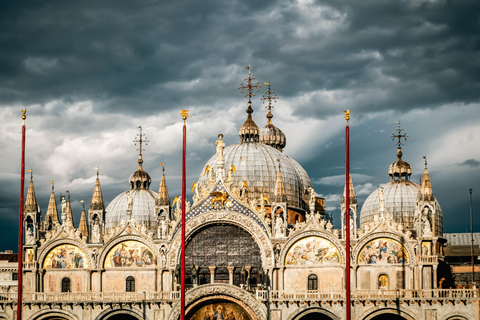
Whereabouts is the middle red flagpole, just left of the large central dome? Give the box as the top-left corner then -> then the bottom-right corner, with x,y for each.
180,109 -> 188,320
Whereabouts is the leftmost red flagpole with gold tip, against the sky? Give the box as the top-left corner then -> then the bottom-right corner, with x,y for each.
17,109 -> 27,320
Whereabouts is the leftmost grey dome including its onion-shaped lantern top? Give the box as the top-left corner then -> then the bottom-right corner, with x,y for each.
105,154 -> 157,231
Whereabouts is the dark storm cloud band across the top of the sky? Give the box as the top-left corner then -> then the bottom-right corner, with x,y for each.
0,1 -> 480,117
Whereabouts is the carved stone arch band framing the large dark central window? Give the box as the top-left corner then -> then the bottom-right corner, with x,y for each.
169,210 -> 273,268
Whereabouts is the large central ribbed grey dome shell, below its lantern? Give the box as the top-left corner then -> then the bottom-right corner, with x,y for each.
198,142 -> 312,209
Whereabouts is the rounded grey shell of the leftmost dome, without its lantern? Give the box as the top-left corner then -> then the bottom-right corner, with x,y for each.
105,188 -> 157,229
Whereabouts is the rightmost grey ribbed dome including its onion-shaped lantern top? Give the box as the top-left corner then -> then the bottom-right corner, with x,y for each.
360,148 -> 442,235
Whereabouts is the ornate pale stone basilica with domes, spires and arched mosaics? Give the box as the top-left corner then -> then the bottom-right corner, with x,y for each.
0,69 -> 480,320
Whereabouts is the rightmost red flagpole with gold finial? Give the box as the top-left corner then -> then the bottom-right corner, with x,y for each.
345,110 -> 352,320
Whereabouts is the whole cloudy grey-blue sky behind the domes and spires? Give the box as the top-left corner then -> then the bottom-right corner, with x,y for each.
0,0 -> 480,251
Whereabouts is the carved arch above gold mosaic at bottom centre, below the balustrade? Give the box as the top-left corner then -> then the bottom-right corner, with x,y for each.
167,283 -> 267,320
